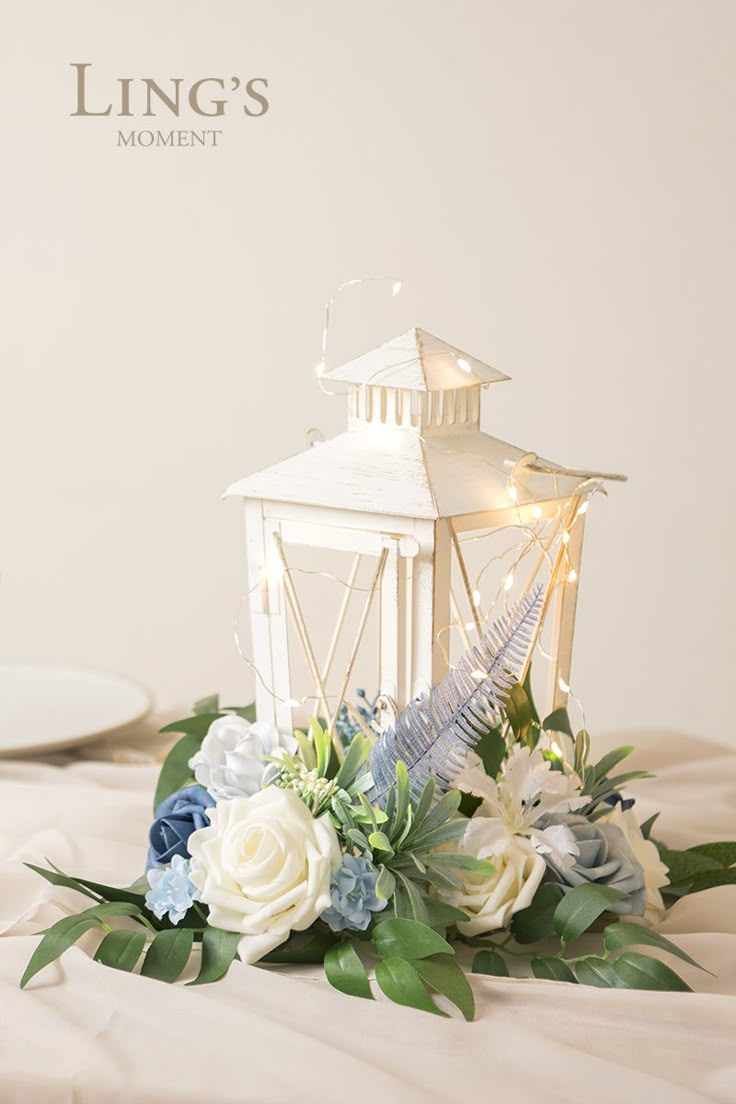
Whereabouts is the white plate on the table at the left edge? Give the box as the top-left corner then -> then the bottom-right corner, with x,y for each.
0,662 -> 151,756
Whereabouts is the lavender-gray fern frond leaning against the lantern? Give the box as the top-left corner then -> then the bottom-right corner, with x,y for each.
366,585 -> 544,806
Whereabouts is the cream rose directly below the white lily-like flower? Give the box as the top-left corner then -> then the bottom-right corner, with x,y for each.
441,816 -> 545,935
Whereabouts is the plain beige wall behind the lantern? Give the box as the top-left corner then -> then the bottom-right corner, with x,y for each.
0,0 -> 736,740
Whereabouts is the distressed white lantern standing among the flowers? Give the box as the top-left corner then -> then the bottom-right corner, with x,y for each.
227,329 -> 623,730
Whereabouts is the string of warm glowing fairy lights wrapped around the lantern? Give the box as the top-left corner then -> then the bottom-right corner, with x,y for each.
228,276 -> 606,751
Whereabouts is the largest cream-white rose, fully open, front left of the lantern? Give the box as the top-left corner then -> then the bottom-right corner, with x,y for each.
188,786 -> 340,963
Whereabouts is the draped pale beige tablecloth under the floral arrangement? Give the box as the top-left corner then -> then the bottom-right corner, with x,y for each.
0,733 -> 736,1104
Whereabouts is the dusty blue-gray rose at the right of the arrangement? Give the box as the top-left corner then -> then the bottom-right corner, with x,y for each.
538,813 -> 647,916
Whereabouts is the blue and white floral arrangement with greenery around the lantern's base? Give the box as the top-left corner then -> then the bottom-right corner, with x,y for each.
21,592 -> 736,1019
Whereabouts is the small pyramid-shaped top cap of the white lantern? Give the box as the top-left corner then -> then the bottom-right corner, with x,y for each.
324,327 -> 509,391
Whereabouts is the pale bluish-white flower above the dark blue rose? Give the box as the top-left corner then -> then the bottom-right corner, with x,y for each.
189,715 -> 297,802
